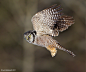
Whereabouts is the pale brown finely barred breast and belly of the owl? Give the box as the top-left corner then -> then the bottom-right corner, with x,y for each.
34,35 -> 56,47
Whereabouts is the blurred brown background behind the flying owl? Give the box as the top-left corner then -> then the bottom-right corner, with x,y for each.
0,0 -> 86,72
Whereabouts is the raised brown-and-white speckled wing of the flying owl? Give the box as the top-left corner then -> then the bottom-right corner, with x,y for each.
31,4 -> 74,36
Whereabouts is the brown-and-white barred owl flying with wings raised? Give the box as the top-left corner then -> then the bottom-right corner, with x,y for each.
24,4 -> 75,57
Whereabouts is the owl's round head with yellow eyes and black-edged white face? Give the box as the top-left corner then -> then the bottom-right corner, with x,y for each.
24,31 -> 36,43
